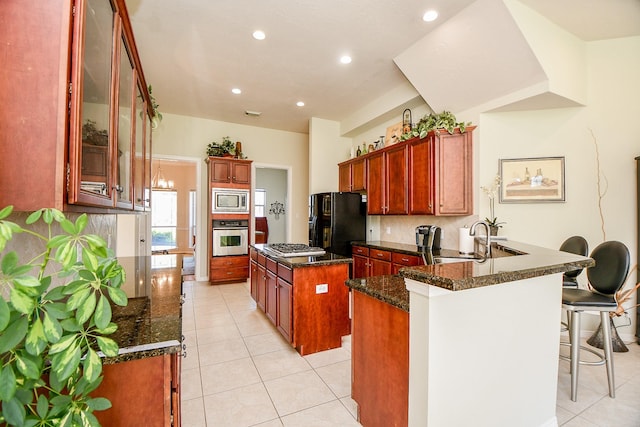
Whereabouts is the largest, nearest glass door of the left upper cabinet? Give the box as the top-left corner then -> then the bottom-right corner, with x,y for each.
69,0 -> 117,206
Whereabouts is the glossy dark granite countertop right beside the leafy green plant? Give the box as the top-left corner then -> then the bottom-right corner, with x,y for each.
103,254 -> 182,364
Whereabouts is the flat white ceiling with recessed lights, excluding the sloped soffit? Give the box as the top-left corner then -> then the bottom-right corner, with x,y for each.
126,0 -> 640,133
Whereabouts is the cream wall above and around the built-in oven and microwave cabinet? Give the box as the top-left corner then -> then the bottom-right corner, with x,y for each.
153,113 -> 309,280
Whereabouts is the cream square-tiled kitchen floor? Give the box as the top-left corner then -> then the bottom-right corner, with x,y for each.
182,282 -> 640,427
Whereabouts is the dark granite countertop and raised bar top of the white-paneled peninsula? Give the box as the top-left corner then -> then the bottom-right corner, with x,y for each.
347,241 -> 594,311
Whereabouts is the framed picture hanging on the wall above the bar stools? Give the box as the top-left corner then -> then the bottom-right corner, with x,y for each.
500,157 -> 565,203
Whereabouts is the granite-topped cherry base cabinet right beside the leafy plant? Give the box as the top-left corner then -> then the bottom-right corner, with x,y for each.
94,254 -> 183,426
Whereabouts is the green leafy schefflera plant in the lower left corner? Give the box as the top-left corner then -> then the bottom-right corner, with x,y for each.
0,206 -> 128,427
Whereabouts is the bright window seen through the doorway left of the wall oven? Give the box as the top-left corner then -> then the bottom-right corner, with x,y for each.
151,190 -> 178,251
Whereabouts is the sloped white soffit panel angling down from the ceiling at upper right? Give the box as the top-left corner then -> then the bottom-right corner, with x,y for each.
394,0 -> 548,113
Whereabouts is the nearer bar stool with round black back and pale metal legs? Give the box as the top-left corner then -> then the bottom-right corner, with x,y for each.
560,241 -> 629,402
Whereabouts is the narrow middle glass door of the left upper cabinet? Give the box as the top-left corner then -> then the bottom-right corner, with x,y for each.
115,38 -> 135,209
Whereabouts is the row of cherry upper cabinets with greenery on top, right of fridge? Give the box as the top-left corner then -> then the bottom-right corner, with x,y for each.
338,126 -> 475,216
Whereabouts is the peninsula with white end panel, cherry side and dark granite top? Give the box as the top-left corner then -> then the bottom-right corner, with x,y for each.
347,241 -> 593,426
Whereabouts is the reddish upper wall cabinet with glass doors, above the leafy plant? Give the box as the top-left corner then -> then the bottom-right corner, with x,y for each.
0,0 -> 151,211
